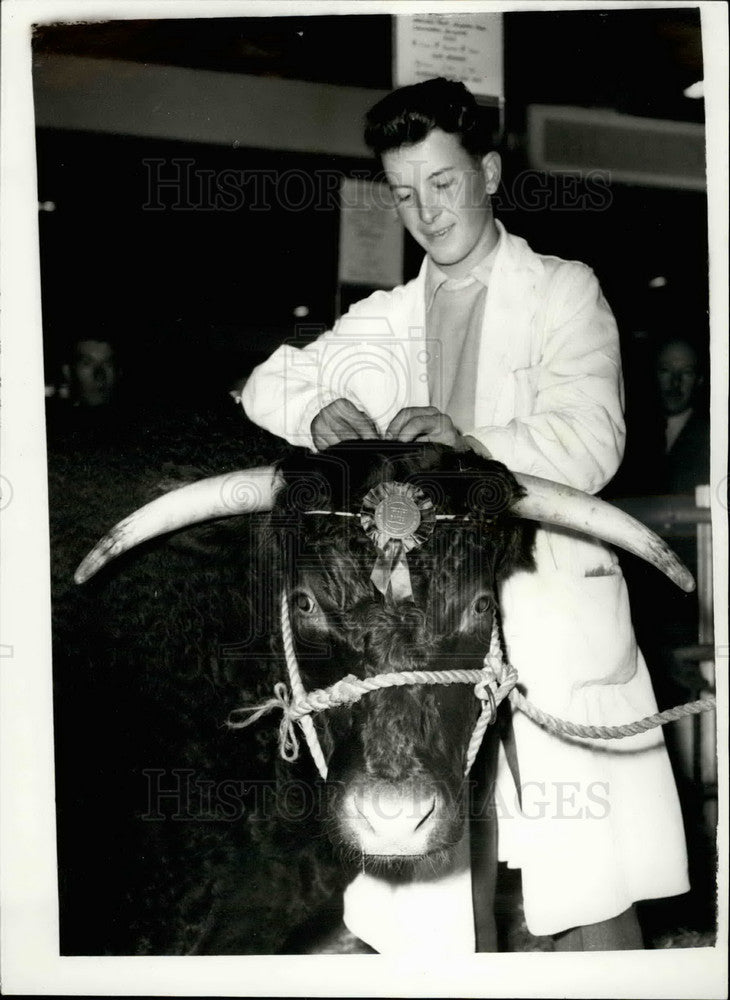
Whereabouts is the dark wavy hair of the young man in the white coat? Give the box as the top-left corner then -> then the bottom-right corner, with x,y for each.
365,77 -> 493,156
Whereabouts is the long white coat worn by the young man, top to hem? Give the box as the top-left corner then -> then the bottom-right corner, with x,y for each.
242,223 -> 689,952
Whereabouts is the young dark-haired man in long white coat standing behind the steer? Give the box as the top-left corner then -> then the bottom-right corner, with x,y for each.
242,79 -> 688,951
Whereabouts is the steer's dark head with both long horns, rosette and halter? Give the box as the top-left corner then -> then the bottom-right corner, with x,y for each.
76,441 -> 693,948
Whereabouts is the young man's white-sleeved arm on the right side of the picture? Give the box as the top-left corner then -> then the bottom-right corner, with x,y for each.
469,263 -> 625,493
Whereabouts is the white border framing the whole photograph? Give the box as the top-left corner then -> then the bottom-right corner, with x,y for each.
0,0 -> 730,1000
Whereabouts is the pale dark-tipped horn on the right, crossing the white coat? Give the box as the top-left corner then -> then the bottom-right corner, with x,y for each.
512,473 -> 695,593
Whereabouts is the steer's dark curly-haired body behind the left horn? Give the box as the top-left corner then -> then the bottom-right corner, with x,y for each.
49,405 -> 345,955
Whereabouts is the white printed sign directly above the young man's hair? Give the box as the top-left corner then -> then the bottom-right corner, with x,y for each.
393,13 -> 504,101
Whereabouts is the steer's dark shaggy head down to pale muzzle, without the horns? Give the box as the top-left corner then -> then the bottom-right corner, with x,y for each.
271,441 -> 532,859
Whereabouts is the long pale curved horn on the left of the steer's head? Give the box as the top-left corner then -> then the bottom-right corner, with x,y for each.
74,466 -> 281,583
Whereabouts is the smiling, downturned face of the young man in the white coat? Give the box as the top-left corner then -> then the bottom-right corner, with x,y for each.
382,129 -> 500,278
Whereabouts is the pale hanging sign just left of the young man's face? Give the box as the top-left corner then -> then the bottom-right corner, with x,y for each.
338,177 -> 403,288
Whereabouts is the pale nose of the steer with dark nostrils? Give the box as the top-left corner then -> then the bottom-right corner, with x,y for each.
343,783 -> 443,855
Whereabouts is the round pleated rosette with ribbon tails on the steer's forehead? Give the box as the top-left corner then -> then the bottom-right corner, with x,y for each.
360,483 -> 436,601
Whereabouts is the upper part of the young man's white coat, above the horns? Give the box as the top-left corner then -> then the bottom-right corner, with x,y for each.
242,223 -> 624,493
